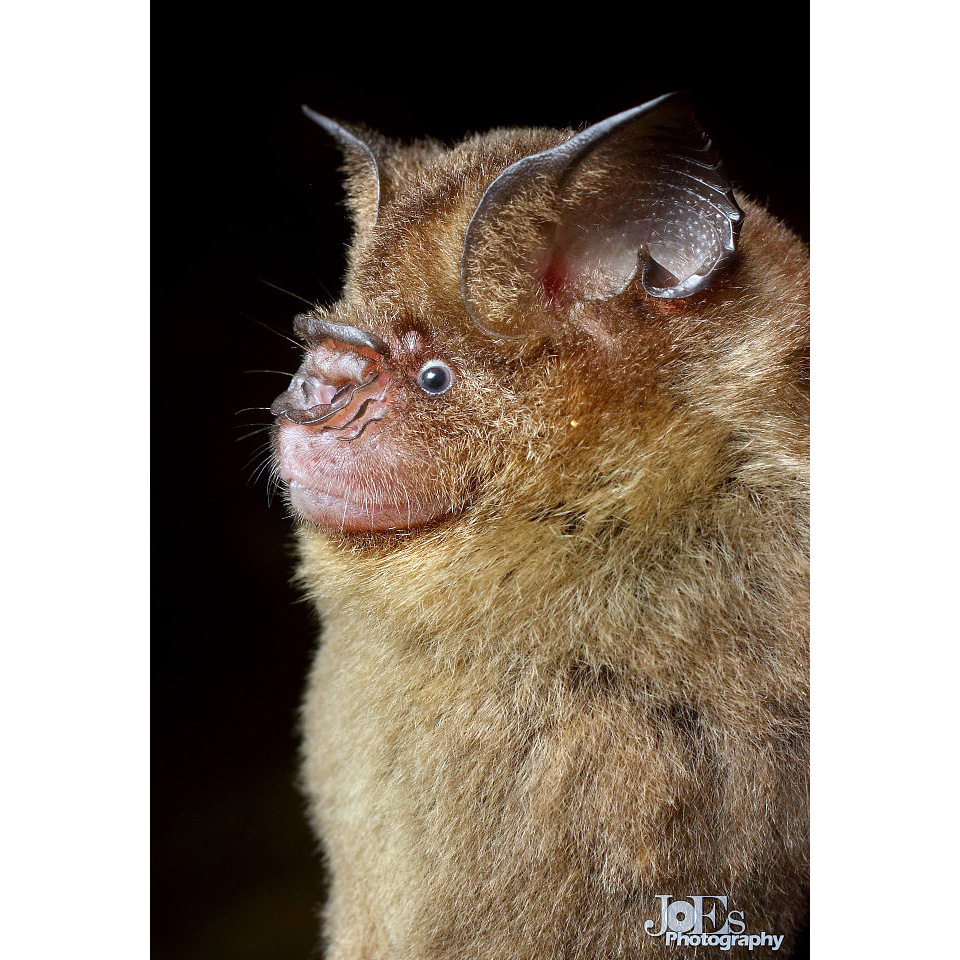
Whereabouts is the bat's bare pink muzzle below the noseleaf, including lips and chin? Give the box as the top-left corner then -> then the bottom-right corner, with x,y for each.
276,419 -> 450,533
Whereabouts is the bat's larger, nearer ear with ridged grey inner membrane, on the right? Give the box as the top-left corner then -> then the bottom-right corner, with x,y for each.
460,93 -> 743,336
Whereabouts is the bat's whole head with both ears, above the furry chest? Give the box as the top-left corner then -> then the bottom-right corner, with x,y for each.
272,94 -> 802,542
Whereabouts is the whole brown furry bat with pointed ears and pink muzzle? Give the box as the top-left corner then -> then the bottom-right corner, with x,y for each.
271,93 -> 809,960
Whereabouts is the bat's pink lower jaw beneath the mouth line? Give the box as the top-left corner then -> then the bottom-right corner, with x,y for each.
287,479 -> 447,533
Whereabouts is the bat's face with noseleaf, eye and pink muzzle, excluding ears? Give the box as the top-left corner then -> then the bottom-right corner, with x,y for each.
272,310 -> 492,533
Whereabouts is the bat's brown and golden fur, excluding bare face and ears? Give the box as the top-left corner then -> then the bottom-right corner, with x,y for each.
286,124 -> 808,960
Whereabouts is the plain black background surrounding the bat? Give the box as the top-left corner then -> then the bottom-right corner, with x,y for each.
156,15 -> 809,960
